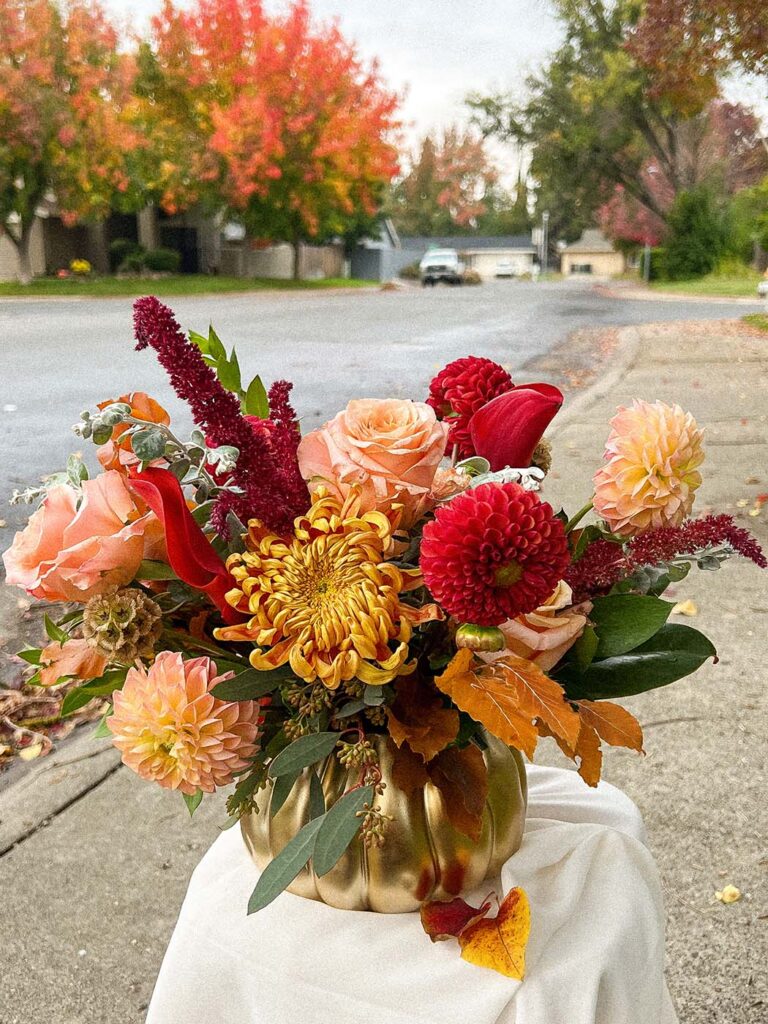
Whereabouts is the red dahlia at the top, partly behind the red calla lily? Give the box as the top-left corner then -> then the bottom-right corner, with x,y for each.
427,355 -> 514,459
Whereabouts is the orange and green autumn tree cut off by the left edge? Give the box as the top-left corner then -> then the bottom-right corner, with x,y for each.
0,0 -> 137,282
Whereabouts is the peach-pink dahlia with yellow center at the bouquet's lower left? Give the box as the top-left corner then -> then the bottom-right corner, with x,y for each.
106,651 -> 261,796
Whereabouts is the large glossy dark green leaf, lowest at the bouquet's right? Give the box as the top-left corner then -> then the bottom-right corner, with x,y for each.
559,624 -> 717,700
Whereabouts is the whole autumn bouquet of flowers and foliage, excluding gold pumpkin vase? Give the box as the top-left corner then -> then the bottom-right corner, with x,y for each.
4,298 -> 766,973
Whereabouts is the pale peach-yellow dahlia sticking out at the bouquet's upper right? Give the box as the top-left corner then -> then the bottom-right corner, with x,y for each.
594,400 -> 703,537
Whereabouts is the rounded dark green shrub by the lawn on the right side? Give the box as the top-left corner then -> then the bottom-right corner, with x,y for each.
665,188 -> 725,281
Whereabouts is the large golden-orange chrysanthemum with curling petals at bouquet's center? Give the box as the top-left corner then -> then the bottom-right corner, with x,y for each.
216,488 -> 438,689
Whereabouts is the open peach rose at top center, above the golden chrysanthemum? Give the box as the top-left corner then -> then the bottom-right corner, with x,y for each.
299,398 -> 449,526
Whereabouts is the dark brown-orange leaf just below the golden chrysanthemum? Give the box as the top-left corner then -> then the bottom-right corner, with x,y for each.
387,676 -> 459,761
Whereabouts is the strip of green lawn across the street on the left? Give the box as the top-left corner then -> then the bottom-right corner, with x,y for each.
0,273 -> 376,298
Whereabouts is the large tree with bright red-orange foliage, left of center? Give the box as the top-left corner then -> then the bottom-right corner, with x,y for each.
140,0 -> 399,275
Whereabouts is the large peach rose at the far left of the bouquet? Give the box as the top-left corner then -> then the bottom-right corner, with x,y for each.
3,470 -> 164,602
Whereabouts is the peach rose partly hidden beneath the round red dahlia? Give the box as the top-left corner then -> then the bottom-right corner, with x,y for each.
479,580 -> 592,672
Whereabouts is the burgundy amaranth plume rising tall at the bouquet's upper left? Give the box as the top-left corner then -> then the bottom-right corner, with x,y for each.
133,296 -> 309,534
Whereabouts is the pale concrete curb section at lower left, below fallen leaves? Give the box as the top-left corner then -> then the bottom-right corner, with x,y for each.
0,724 -> 120,857
